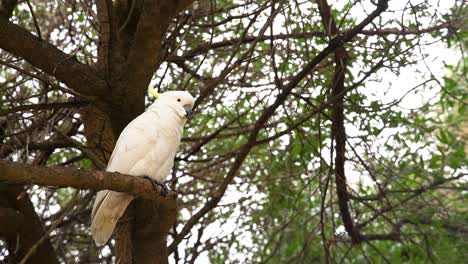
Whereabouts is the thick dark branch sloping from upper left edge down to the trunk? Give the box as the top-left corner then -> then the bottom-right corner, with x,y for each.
0,19 -> 106,96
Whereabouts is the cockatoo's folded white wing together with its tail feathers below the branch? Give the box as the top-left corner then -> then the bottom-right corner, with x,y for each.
91,111 -> 159,246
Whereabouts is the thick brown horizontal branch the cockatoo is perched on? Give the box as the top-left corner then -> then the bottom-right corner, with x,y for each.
0,160 -> 171,200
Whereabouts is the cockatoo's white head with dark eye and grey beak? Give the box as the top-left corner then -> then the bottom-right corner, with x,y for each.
155,91 -> 195,120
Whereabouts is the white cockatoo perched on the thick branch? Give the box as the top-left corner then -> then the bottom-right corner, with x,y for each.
91,91 -> 194,246
